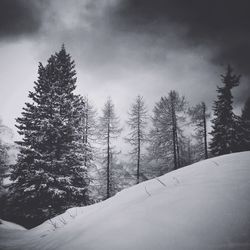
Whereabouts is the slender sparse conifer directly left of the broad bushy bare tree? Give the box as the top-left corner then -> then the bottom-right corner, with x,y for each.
126,95 -> 148,183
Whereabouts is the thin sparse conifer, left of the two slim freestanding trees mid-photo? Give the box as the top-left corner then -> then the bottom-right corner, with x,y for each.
99,98 -> 121,198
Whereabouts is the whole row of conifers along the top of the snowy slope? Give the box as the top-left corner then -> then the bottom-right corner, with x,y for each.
0,46 -> 250,227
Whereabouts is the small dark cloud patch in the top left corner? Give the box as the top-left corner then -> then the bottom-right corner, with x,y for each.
0,0 -> 48,39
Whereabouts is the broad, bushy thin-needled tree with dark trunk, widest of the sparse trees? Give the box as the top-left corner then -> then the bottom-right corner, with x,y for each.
149,91 -> 185,174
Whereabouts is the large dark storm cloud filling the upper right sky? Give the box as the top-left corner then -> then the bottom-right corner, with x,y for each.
116,0 -> 250,75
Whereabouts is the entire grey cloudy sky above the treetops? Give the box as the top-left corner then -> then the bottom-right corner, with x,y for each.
0,0 -> 250,139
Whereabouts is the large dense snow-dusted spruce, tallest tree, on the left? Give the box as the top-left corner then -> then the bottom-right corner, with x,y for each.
8,46 -> 89,226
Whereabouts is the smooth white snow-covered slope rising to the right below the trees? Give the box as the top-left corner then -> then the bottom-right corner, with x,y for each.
0,152 -> 250,250
